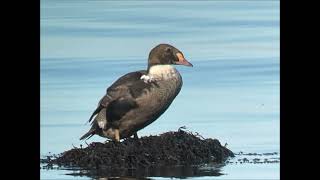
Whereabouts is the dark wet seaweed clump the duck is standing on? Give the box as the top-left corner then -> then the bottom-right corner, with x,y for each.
47,129 -> 234,170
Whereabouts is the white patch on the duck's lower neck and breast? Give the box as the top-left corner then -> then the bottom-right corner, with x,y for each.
140,65 -> 179,83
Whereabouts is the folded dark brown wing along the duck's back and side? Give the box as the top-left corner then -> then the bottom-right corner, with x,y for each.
80,70 -> 151,139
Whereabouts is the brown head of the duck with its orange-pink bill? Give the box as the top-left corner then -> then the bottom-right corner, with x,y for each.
148,44 -> 193,69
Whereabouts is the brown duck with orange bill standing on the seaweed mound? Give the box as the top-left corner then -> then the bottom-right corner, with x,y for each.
80,44 -> 193,142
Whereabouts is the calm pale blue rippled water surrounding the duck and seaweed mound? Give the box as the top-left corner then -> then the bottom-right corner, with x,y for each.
40,0 -> 280,179
